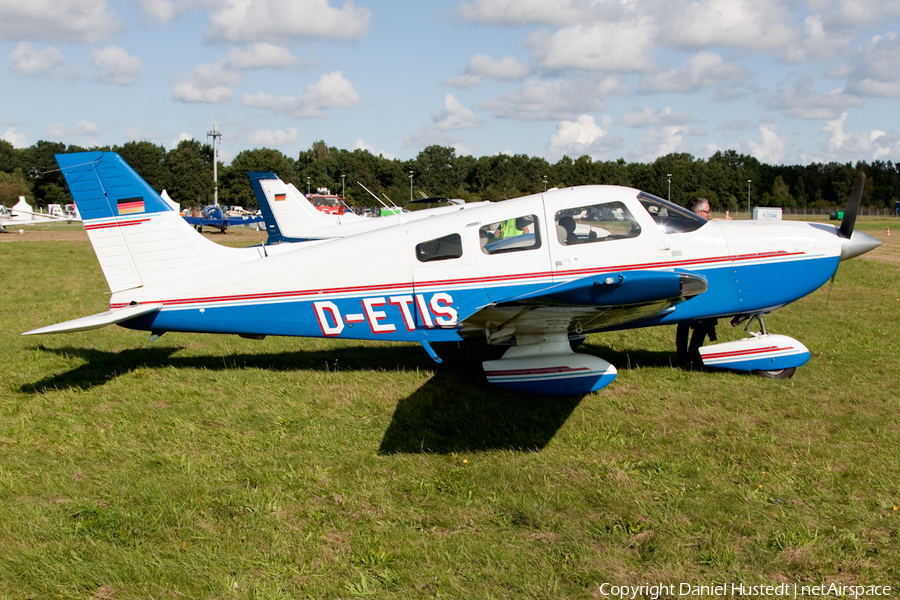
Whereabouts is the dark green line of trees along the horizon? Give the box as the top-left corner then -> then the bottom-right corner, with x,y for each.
0,140 -> 900,210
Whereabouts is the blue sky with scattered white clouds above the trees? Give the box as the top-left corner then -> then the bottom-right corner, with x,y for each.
0,0 -> 900,164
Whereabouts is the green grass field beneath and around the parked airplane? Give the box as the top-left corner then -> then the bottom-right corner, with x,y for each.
0,220 -> 900,600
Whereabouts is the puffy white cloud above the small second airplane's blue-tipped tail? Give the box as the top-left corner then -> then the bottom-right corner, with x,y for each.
243,71 -> 362,118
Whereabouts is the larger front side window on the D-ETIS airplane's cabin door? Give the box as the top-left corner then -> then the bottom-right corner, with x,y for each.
553,202 -> 641,246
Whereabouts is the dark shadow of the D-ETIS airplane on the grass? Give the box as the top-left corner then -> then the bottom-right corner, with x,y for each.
20,344 -> 671,454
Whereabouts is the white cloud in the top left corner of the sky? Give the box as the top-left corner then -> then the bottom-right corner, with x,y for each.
0,0 -> 123,44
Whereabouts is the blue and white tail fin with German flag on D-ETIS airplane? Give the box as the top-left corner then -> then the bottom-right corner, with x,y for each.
56,152 -> 244,292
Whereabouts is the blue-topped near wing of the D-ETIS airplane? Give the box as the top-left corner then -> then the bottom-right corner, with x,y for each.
460,271 -> 707,337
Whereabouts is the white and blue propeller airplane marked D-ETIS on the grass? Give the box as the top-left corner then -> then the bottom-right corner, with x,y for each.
25,152 -> 880,394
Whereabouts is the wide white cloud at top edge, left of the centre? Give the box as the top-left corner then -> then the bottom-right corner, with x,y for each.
206,0 -> 372,43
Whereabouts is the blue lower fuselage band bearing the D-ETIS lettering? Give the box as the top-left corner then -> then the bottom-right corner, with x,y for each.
122,256 -> 838,342
